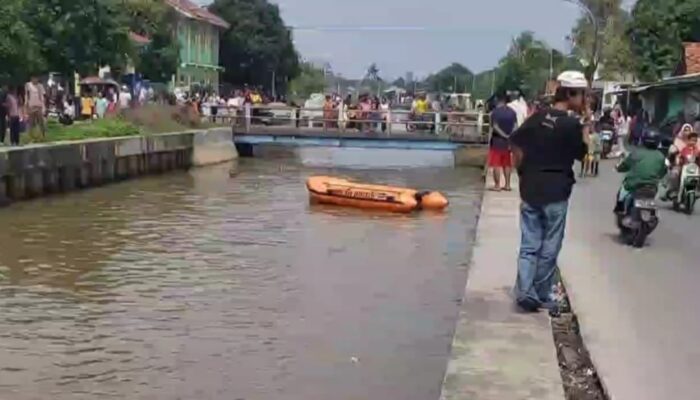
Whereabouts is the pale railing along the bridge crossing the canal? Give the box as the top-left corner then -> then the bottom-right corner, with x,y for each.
206,105 -> 490,141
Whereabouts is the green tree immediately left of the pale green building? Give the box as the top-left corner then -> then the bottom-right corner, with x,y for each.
123,0 -> 180,82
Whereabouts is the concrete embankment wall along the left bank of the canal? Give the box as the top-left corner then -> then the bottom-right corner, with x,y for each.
0,128 -> 238,205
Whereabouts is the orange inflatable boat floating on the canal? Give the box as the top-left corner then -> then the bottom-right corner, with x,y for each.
306,176 -> 449,213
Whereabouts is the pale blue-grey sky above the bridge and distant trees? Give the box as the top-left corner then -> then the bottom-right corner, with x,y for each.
194,0 -> 634,78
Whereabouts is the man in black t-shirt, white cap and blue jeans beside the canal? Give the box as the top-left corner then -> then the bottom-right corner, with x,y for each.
511,71 -> 588,311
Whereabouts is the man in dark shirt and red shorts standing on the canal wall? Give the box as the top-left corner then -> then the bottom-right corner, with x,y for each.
488,94 -> 517,191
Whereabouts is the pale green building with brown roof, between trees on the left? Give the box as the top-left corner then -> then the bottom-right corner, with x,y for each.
165,0 -> 229,90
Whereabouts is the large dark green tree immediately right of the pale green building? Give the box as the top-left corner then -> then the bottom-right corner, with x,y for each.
209,0 -> 300,87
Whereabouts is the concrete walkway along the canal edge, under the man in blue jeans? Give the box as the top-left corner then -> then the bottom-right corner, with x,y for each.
441,183 -> 564,400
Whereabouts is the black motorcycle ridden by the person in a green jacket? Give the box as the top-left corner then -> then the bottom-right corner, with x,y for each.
616,186 -> 659,248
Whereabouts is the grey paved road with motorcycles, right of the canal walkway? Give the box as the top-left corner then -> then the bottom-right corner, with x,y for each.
560,162 -> 700,400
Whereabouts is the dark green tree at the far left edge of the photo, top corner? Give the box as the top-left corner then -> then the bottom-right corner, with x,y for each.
0,0 -> 44,84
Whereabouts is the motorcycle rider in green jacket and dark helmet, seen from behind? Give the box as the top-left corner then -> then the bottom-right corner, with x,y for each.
614,127 -> 666,213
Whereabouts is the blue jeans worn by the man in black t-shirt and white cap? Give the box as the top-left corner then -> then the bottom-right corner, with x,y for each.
515,201 -> 569,308
